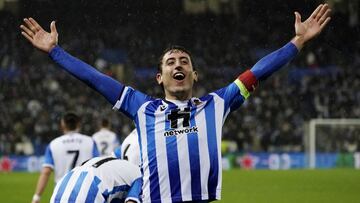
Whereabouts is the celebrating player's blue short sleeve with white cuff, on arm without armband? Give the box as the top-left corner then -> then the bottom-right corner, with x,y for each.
113,86 -> 152,120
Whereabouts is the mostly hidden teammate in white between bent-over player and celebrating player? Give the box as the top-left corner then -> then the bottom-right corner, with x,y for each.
113,129 -> 141,166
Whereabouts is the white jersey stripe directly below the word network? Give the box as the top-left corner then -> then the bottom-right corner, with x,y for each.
176,127 -> 192,201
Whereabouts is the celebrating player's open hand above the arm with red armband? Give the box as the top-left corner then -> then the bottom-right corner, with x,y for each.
295,4 -> 331,43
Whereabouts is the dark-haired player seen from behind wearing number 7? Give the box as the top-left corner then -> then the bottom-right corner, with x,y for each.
32,113 -> 99,203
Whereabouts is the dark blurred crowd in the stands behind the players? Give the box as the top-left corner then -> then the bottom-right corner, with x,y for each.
0,0 -> 360,155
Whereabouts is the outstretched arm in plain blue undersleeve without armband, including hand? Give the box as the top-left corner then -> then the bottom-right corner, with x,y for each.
20,18 -> 124,105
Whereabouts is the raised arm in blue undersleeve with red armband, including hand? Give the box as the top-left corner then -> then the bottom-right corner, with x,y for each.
239,4 -> 331,91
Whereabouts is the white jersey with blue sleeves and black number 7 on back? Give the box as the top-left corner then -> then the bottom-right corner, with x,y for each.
43,131 -> 99,183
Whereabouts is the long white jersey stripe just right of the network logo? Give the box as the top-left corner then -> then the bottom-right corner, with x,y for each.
195,109 -> 210,199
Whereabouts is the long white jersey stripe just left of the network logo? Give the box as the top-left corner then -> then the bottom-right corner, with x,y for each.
155,106 -> 171,203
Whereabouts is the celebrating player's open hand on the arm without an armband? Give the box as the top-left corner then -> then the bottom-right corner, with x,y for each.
20,18 -> 58,53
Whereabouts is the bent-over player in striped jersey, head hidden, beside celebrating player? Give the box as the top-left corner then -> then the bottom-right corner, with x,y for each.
50,157 -> 142,203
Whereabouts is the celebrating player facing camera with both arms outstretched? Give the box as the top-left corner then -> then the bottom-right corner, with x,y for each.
20,4 -> 330,203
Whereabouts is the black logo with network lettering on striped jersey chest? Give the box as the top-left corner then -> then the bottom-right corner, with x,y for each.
164,107 -> 198,137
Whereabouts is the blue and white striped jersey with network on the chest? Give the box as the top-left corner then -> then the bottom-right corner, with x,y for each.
114,79 -> 249,203
